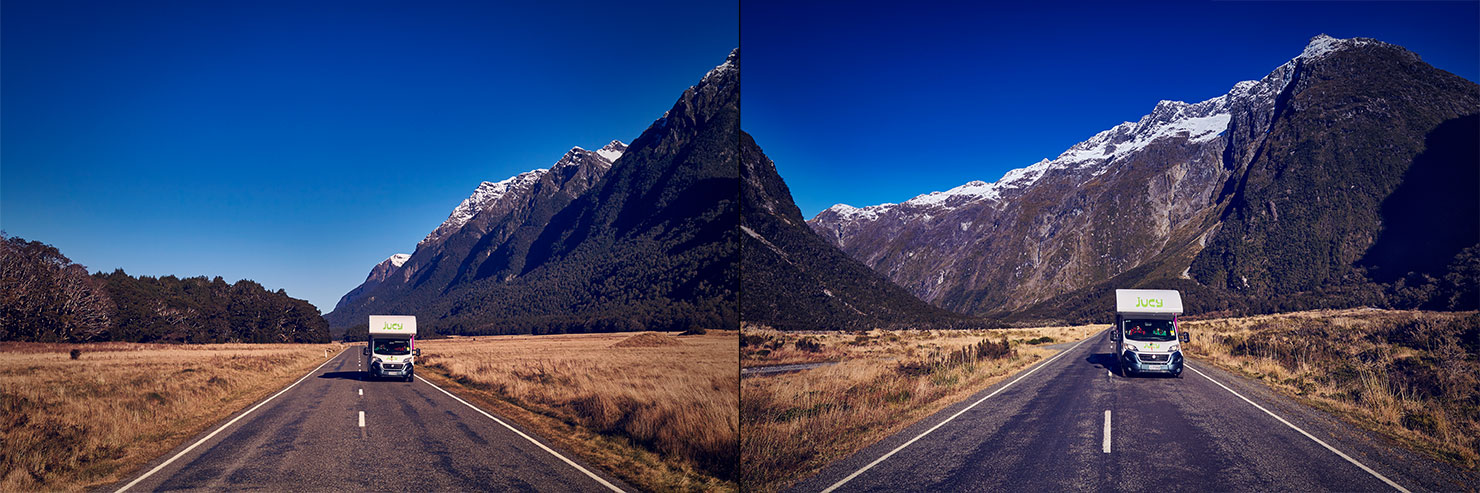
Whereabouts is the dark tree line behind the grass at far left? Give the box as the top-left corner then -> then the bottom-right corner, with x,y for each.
0,234 -> 329,343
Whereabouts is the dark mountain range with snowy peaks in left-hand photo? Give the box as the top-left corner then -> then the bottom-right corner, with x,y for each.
324,50 -> 740,333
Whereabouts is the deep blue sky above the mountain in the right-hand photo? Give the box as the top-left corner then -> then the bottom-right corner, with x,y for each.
740,0 -> 1480,218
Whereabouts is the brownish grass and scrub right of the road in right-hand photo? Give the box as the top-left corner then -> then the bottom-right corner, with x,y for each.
1183,309 -> 1480,471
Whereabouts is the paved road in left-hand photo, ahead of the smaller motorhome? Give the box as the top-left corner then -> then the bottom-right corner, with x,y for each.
105,346 -> 630,492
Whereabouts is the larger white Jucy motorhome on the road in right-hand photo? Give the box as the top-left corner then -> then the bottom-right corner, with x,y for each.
1110,289 -> 1188,378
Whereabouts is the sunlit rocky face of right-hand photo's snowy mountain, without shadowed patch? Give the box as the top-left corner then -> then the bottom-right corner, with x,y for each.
810,36 -> 1480,314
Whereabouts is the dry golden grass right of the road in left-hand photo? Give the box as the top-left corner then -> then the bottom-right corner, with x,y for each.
417,330 -> 740,492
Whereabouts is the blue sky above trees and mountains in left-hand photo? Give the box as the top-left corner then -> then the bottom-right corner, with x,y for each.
0,0 -> 739,312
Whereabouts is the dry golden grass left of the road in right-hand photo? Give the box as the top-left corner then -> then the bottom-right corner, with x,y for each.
740,326 -> 1104,492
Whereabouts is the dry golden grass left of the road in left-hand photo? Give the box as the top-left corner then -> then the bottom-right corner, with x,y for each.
0,342 -> 340,492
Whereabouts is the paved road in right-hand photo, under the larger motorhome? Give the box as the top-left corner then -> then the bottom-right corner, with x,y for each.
792,332 -> 1480,492
